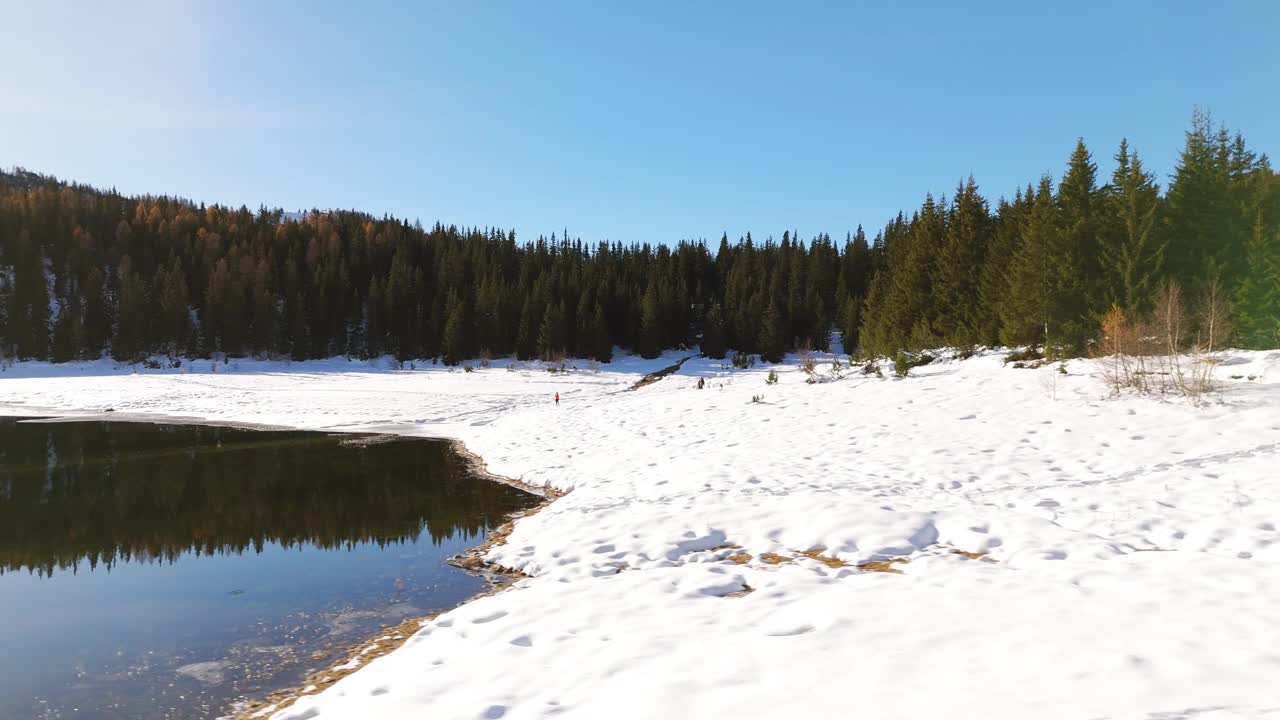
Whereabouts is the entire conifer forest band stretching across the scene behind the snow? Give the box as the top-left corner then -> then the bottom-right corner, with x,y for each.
0,113 -> 1280,364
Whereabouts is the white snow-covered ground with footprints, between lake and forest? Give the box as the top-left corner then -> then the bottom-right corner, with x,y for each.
0,352 -> 1280,720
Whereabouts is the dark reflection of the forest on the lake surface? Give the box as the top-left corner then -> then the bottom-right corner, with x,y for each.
0,419 -> 513,575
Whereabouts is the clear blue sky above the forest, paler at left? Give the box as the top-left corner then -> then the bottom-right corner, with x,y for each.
0,0 -> 1280,242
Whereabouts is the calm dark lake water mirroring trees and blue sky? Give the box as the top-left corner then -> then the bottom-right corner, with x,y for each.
0,418 -> 535,720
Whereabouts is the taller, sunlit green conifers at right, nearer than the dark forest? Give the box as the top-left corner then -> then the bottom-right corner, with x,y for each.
860,113 -> 1280,355
